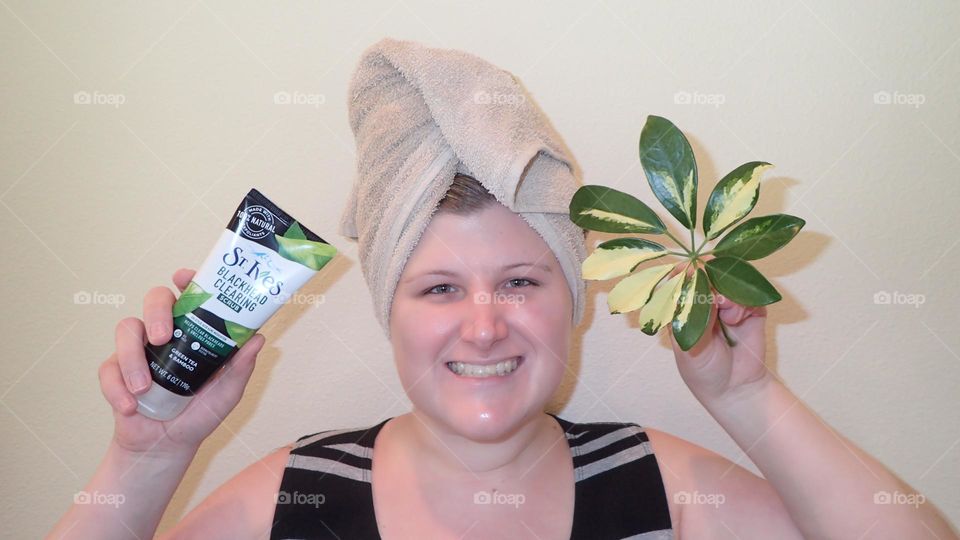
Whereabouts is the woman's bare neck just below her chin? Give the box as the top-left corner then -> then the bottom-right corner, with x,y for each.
407,409 -> 563,481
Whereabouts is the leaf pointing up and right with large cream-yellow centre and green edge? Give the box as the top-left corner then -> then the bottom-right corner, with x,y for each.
703,161 -> 773,240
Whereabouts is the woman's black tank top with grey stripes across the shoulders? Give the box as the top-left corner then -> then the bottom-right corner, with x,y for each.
270,414 -> 673,540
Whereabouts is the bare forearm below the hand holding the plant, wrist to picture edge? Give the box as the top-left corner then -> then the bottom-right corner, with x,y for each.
704,376 -> 958,539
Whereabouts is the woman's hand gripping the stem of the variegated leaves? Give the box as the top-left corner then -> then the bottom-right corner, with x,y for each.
667,266 -> 773,404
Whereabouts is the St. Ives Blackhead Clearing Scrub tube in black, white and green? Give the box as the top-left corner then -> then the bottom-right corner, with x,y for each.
137,189 -> 337,420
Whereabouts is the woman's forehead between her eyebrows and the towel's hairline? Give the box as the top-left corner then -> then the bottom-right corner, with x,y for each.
404,203 -> 559,274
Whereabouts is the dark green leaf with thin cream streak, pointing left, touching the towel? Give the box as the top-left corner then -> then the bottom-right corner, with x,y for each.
570,185 -> 667,234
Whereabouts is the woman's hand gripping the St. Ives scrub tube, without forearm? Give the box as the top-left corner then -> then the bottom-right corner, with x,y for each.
99,269 -> 264,455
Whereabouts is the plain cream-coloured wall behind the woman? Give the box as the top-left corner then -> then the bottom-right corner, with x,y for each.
0,0 -> 960,538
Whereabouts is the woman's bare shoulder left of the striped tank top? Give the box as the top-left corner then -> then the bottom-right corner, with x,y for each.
161,443 -> 294,539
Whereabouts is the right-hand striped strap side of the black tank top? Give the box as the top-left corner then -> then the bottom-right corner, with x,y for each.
550,414 -> 674,540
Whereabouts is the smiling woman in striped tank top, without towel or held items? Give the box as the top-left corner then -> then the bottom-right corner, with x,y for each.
51,37 -> 956,539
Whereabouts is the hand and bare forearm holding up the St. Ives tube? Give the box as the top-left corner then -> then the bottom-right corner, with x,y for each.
48,270 -> 264,539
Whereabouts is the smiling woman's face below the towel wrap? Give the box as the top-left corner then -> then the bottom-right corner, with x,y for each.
390,203 -> 573,441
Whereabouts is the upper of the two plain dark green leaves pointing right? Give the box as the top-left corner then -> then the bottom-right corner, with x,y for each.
713,214 -> 806,261
